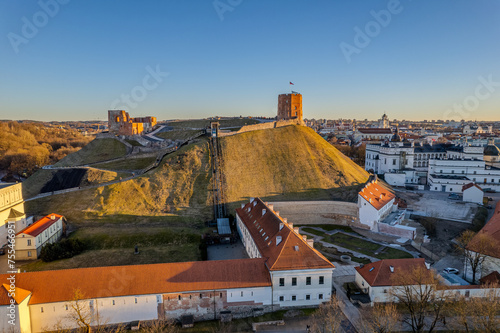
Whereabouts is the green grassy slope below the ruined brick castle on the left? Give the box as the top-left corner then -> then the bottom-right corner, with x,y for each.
54,138 -> 127,166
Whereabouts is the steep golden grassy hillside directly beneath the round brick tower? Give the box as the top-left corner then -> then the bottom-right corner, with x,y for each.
221,125 -> 368,202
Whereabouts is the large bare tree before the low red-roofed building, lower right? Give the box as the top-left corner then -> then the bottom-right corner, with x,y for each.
390,266 -> 447,332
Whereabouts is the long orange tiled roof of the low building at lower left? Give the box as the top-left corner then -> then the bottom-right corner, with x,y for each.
0,258 -> 271,305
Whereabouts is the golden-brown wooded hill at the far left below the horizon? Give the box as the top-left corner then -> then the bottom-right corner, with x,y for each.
0,121 -> 93,177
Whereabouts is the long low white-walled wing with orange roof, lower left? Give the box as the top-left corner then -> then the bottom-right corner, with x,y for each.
0,259 -> 273,333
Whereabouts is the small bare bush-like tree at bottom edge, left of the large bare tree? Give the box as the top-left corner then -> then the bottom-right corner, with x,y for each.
363,303 -> 401,333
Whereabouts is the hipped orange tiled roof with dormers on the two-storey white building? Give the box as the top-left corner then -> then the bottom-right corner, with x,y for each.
236,198 -> 335,271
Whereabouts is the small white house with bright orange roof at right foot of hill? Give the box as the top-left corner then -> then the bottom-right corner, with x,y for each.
358,179 -> 397,231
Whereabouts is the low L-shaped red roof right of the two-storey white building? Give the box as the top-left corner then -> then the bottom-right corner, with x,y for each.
356,258 -> 427,287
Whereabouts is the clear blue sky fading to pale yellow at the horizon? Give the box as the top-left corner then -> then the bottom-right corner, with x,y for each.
0,0 -> 500,120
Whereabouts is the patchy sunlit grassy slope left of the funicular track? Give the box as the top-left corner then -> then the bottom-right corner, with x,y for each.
27,141 -> 211,224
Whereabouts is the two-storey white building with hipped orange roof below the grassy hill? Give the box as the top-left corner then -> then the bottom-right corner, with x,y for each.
236,198 -> 335,306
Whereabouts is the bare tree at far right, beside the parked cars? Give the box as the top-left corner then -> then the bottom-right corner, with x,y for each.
456,230 -> 495,283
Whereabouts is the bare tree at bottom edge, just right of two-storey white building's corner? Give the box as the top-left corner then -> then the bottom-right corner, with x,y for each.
311,295 -> 343,333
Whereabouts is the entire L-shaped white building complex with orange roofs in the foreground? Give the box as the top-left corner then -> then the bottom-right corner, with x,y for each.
0,199 -> 334,333
